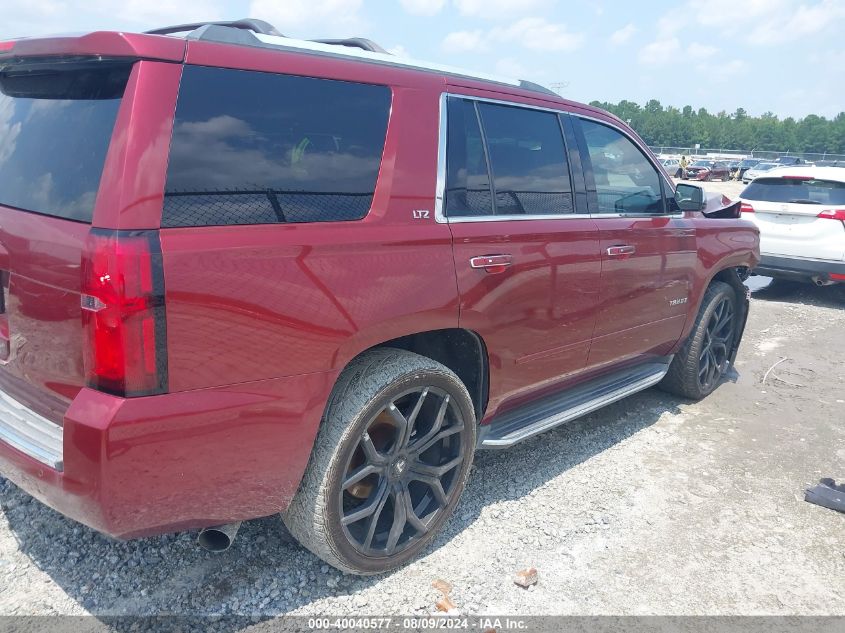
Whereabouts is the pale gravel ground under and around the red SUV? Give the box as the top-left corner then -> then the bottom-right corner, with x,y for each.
0,205 -> 845,616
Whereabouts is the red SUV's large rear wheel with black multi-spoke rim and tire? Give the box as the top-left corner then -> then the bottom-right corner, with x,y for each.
282,348 -> 476,575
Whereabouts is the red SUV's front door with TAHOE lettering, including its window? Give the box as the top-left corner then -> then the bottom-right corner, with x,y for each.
573,117 -> 697,367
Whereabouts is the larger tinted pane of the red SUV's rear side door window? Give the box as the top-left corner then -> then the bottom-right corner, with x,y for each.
478,103 -> 574,215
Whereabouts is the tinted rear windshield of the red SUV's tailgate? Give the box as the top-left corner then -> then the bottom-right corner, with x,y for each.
0,62 -> 131,222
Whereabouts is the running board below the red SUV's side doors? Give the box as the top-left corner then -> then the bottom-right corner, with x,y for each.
478,356 -> 672,448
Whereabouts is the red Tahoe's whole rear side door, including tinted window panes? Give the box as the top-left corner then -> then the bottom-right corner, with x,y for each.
442,96 -> 601,410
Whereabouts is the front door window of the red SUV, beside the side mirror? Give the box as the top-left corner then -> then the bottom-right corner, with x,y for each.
580,119 -> 665,214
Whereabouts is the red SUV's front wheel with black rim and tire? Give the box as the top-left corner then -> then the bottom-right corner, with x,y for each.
660,281 -> 738,400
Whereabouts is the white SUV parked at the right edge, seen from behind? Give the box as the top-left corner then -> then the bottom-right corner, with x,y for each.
740,167 -> 845,286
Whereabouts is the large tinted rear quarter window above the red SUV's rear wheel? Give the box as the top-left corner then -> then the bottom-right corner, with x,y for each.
162,66 -> 391,227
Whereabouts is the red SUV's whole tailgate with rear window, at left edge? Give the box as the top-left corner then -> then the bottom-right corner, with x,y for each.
0,58 -> 132,420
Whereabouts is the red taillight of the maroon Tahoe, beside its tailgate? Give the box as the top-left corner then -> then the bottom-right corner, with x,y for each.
82,229 -> 167,396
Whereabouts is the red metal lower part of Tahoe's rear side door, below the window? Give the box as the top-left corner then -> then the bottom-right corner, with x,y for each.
450,219 -> 601,416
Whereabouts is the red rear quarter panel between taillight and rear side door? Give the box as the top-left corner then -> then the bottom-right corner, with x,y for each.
162,222 -> 458,390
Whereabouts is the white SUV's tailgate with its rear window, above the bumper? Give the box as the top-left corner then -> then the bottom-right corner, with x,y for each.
741,175 -> 845,261
